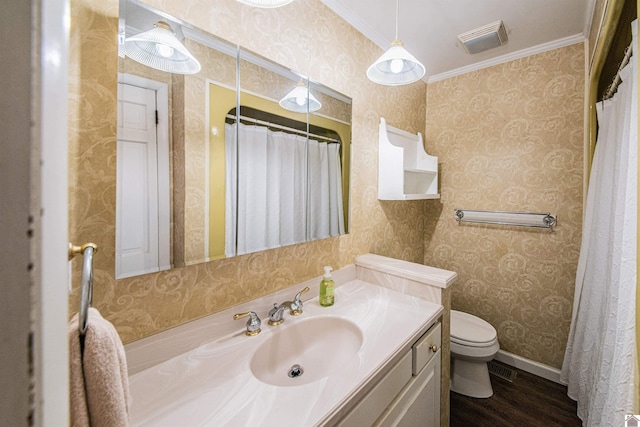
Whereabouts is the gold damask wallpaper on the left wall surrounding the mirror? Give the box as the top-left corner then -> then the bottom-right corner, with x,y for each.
69,0 -> 426,343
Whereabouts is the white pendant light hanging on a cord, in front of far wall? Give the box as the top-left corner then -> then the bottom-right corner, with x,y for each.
367,0 -> 426,86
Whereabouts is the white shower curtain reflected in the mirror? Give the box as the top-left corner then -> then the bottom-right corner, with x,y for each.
225,124 -> 344,256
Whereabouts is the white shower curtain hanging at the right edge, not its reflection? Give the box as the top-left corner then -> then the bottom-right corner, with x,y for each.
561,22 -> 638,426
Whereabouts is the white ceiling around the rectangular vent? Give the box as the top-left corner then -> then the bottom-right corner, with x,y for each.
322,0 -> 595,82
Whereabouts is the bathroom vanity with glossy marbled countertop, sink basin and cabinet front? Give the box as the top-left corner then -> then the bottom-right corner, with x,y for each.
126,256 -> 455,426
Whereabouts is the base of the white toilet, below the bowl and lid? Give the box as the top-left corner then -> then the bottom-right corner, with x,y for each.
451,357 -> 493,399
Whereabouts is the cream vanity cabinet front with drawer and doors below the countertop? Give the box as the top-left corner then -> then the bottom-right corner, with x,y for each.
337,323 -> 442,427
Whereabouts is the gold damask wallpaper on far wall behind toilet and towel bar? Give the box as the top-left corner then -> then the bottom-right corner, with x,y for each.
425,44 -> 584,368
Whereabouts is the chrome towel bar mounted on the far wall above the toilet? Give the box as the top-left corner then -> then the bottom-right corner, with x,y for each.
454,209 -> 557,228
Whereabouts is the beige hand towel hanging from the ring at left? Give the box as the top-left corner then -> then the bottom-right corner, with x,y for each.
69,308 -> 130,427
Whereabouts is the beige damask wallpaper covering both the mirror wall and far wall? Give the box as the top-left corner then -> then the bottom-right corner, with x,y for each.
69,0 -> 584,425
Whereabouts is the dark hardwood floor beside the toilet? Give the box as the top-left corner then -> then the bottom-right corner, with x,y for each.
451,368 -> 582,427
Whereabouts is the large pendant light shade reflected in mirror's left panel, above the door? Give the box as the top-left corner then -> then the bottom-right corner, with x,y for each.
124,21 -> 200,74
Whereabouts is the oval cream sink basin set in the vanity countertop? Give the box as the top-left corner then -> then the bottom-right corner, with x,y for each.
251,317 -> 363,386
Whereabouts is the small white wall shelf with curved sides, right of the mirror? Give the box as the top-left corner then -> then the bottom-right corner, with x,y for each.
378,117 -> 440,200
